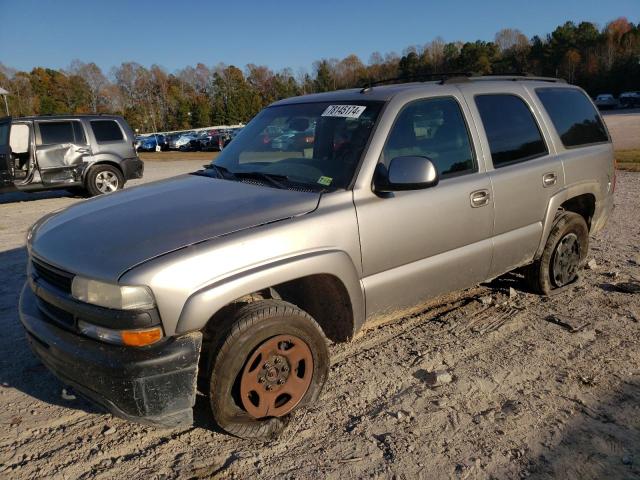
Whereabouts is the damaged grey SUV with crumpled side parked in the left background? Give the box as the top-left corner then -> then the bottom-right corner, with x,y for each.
0,115 -> 144,195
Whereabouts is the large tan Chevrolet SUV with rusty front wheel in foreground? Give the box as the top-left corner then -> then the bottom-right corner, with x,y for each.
20,77 -> 615,437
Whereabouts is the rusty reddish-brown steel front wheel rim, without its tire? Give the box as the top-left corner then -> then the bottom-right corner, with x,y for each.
240,335 -> 313,418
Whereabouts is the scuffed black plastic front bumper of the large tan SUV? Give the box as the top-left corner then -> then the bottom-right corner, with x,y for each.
19,284 -> 202,427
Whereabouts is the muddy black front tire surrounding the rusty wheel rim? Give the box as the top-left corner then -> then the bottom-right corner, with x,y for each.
209,300 -> 329,439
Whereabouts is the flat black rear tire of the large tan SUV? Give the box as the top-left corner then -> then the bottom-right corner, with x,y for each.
525,212 -> 589,295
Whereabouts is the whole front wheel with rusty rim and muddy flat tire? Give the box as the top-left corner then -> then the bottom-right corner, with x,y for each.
209,300 -> 329,438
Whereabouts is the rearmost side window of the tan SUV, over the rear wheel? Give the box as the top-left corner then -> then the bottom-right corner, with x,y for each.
536,88 -> 609,148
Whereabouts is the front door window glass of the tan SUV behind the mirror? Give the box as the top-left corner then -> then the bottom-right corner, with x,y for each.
381,97 -> 476,178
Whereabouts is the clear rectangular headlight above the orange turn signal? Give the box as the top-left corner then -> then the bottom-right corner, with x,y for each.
71,277 -> 155,310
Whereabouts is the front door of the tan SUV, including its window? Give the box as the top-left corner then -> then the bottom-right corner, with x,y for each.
354,92 -> 494,317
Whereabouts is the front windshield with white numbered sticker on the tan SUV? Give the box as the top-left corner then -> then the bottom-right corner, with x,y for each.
210,102 -> 383,189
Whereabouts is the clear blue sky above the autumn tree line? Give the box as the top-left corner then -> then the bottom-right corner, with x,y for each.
0,0 -> 640,73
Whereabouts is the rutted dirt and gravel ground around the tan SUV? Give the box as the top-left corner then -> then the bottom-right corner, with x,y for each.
0,160 -> 640,479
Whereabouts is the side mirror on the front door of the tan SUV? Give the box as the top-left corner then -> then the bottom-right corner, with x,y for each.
374,156 -> 440,193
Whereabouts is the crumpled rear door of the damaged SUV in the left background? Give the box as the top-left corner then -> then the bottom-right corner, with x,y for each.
36,120 -> 91,185
